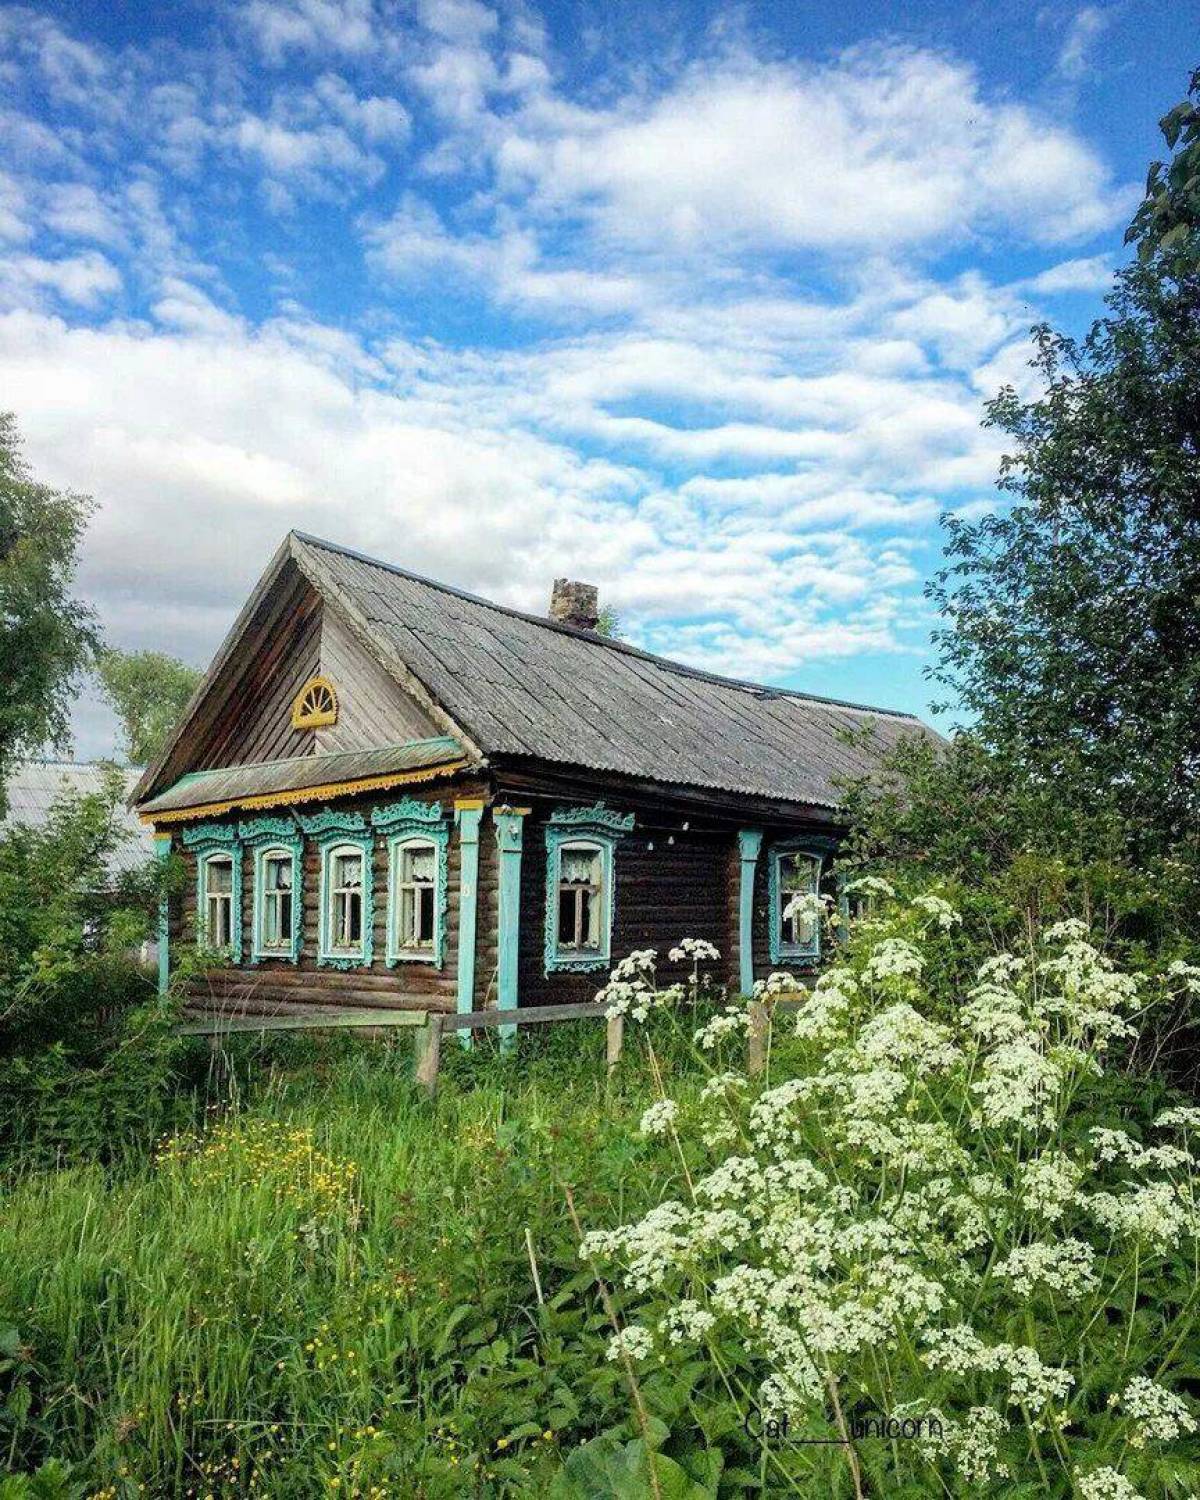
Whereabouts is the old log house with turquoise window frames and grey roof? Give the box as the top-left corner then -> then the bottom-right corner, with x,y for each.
132,533 -> 929,1011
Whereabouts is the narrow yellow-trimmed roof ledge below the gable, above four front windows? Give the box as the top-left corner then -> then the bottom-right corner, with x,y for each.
138,735 -> 465,818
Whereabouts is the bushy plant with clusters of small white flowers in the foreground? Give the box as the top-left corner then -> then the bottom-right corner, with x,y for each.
581,882 -> 1200,1500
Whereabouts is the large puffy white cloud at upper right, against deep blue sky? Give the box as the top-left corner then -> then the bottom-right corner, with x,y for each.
486,47 -> 1124,254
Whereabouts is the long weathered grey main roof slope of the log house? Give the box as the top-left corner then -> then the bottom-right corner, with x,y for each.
291,533 -> 932,807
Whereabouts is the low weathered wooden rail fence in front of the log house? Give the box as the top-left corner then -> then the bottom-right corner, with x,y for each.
179,1001 -> 795,1098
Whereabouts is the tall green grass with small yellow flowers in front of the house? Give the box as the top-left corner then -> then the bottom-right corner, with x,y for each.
0,1025 -> 686,1496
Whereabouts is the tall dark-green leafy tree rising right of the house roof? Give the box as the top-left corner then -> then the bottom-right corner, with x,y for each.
929,220 -> 1200,860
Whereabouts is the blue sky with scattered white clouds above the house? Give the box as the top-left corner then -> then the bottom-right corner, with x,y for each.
0,0 -> 1200,756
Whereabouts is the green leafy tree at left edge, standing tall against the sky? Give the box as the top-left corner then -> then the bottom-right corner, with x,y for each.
0,413 -> 98,812
